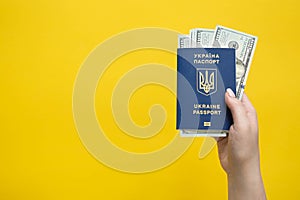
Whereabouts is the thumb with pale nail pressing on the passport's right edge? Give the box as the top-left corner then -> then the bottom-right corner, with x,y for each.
225,88 -> 246,124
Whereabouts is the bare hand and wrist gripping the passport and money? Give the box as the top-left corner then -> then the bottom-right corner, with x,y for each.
218,89 -> 266,200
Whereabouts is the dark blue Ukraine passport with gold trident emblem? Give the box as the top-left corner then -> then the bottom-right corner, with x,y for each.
176,48 -> 236,136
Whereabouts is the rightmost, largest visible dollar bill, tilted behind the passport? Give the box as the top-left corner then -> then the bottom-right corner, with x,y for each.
213,26 -> 257,99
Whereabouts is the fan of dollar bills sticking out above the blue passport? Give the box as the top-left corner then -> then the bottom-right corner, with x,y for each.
178,26 -> 257,99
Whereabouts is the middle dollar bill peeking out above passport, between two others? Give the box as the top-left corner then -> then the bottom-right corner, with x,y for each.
190,28 -> 214,48
